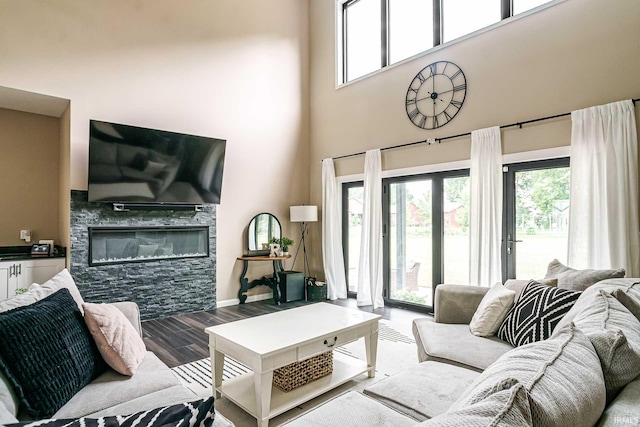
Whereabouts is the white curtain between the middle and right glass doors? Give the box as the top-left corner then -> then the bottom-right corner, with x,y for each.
469,126 -> 502,286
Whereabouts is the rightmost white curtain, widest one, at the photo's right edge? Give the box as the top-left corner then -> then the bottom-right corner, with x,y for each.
568,100 -> 640,277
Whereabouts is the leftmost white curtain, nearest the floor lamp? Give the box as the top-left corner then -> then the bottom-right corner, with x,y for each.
322,159 -> 347,300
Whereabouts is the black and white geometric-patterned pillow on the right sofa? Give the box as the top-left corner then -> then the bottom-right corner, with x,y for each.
497,281 -> 581,347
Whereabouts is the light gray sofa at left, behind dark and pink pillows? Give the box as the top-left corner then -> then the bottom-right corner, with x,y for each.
0,270 -> 233,427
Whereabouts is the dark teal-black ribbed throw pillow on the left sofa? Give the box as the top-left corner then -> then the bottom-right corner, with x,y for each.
0,288 -> 107,419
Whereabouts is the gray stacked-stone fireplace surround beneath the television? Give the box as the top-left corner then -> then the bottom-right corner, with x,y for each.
70,190 -> 216,320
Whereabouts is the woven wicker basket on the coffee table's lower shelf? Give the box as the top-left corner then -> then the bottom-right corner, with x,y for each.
273,351 -> 333,391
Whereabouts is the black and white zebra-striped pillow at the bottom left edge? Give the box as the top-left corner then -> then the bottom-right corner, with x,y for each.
7,397 -> 215,427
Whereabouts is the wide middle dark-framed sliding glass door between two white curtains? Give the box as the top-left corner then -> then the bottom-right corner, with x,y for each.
383,171 -> 469,308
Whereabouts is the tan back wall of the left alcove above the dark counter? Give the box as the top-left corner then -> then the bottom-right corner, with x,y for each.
0,109 -> 61,246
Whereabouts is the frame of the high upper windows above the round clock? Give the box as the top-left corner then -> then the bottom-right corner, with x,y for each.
336,0 -> 566,87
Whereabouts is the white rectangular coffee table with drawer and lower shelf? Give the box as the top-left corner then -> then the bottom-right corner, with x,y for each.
205,303 -> 381,427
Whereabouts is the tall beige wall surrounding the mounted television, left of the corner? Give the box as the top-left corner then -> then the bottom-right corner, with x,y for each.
0,0 -> 309,301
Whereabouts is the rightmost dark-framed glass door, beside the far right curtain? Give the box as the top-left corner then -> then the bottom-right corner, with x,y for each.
502,158 -> 569,280
